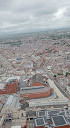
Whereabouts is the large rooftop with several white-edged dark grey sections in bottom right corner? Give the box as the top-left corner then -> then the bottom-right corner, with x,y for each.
26,109 -> 70,128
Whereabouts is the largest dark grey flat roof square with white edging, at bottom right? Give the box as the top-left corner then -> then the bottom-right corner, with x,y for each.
52,116 -> 68,127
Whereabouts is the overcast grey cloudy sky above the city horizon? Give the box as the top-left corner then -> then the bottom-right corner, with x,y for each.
0,0 -> 70,33
